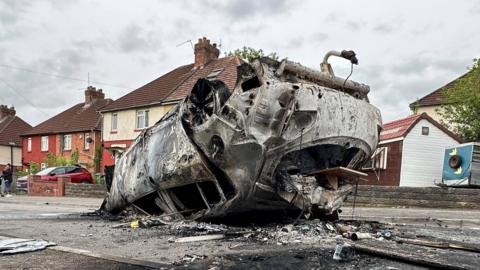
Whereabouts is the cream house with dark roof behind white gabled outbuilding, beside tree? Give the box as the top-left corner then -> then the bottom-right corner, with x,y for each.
410,72 -> 468,123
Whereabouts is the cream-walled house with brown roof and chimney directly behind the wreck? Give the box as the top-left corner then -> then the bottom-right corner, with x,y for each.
100,37 -> 241,169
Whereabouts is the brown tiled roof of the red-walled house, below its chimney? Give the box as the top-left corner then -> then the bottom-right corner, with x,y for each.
22,99 -> 112,136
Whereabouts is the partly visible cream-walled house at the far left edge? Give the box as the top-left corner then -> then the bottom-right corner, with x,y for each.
0,105 -> 32,171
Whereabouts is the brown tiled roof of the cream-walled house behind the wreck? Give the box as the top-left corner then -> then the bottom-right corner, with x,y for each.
101,56 -> 241,111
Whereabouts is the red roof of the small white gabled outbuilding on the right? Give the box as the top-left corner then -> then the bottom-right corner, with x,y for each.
380,113 -> 463,142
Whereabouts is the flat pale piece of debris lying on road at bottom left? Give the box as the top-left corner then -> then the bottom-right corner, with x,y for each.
0,237 -> 57,255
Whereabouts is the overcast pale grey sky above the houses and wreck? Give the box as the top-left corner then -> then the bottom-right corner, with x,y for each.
0,0 -> 480,125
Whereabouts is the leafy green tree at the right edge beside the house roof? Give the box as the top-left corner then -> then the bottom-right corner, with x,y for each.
438,59 -> 480,141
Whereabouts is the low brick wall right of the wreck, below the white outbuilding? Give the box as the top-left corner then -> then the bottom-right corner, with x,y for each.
347,185 -> 480,209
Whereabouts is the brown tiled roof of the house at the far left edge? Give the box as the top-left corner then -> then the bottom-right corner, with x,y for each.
0,115 -> 32,145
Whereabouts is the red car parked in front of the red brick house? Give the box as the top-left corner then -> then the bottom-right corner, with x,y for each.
36,166 -> 95,184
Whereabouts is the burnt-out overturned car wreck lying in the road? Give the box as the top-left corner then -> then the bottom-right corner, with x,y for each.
103,51 -> 381,221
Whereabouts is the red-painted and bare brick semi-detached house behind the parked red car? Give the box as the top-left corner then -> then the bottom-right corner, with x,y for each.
22,86 -> 112,172
